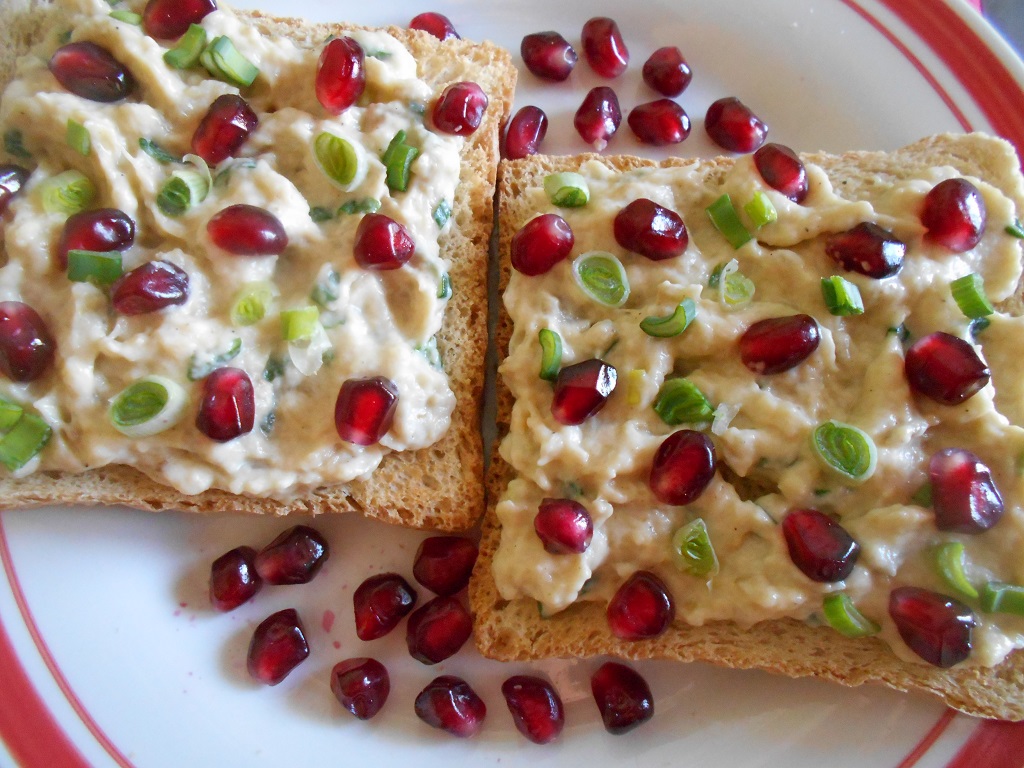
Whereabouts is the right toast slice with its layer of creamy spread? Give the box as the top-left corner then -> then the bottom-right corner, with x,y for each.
470,134 -> 1024,720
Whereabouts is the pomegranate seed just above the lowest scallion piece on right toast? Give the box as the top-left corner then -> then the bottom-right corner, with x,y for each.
782,509 -> 860,582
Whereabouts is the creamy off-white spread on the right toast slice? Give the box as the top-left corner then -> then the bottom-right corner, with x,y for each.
494,151 -> 1024,665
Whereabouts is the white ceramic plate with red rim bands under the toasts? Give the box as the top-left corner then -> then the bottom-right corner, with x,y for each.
0,0 -> 1024,768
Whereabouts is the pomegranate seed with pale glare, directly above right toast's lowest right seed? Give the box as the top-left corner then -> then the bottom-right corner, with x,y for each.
928,449 -> 1002,534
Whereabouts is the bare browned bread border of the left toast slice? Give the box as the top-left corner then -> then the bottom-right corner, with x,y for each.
0,0 -> 516,530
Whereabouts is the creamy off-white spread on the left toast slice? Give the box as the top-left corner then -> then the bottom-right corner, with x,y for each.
0,0 -> 463,498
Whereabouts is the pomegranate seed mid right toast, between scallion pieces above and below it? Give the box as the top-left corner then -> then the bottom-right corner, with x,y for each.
647,429 -> 716,507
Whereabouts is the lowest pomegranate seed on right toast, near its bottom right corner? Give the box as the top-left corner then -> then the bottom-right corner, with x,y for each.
889,587 -> 978,669
